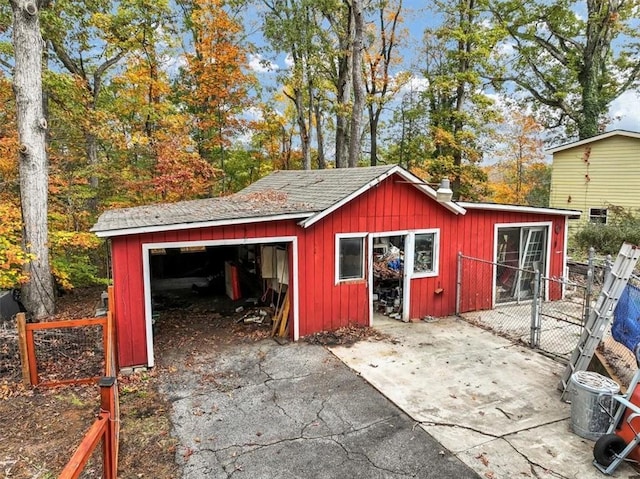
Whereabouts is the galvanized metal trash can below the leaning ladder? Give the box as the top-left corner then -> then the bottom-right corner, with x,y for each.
569,371 -> 620,441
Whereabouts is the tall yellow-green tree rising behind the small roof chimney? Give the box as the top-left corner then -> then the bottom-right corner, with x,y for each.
423,0 -> 500,199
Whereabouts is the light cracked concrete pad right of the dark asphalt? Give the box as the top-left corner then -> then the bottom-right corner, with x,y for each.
331,318 -> 640,479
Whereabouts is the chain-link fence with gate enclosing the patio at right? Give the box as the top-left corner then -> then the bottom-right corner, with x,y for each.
457,251 -> 640,390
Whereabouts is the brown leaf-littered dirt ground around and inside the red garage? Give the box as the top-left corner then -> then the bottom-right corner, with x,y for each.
0,289 -> 376,479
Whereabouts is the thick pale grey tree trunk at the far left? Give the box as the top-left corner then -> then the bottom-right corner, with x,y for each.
11,0 -> 55,318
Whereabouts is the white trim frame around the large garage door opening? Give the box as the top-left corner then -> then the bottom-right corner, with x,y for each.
142,236 -> 300,367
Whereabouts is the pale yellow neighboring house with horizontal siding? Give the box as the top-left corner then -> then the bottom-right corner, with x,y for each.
547,130 -> 640,223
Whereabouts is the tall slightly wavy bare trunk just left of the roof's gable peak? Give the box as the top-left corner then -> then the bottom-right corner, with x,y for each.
348,0 -> 366,168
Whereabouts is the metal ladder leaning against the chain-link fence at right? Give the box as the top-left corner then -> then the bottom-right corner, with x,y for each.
559,243 -> 640,397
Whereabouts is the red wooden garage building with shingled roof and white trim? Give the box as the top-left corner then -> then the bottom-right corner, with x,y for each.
92,165 -> 579,367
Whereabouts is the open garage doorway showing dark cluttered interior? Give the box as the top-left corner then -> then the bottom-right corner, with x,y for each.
145,241 -> 297,366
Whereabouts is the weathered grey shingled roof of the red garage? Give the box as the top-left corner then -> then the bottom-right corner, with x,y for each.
91,165 -> 464,237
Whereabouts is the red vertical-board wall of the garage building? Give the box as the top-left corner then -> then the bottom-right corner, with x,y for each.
107,172 -> 565,366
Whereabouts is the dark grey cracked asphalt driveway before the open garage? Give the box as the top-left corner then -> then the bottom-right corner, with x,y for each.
162,340 -> 479,479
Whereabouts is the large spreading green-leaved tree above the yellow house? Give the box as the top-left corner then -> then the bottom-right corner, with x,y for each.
491,0 -> 640,139
